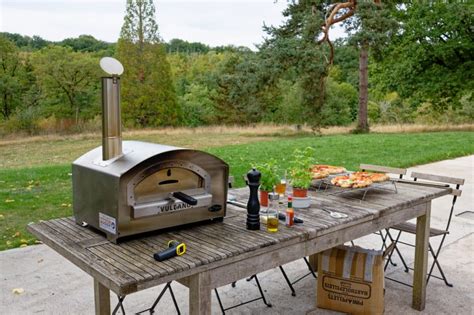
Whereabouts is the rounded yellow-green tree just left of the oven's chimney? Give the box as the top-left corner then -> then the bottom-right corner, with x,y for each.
33,46 -> 99,124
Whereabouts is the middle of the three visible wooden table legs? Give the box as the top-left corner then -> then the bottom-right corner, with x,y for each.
188,272 -> 212,315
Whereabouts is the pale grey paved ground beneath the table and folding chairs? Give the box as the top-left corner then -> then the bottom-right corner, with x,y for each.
0,155 -> 474,315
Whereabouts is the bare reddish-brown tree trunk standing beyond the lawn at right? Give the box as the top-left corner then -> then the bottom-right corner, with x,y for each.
357,44 -> 369,132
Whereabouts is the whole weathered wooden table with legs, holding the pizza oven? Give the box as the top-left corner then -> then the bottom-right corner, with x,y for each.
28,182 -> 451,314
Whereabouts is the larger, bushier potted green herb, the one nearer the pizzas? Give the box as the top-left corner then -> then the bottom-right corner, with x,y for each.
289,147 -> 315,198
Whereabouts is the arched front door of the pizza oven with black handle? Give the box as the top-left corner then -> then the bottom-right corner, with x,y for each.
127,160 -> 212,219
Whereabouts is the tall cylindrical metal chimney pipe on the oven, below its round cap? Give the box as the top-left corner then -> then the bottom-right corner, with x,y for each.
102,76 -> 122,161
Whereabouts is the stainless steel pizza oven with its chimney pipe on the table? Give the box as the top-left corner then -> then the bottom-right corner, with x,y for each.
72,58 -> 229,242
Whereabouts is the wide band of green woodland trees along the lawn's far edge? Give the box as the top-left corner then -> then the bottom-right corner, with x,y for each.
0,2 -> 474,135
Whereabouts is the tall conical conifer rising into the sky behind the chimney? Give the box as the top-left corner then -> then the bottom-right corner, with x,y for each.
117,0 -> 181,127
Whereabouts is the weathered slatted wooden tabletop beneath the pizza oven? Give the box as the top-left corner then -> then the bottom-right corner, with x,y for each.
28,183 -> 451,314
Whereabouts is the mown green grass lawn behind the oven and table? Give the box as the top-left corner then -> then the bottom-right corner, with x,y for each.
0,132 -> 474,250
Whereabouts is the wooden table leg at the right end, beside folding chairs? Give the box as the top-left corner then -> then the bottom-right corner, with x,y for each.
412,202 -> 431,311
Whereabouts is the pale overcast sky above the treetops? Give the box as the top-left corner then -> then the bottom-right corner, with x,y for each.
0,0 -> 340,49
